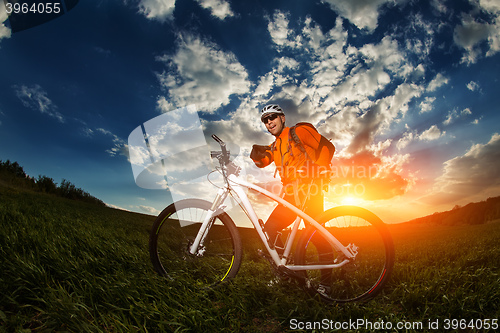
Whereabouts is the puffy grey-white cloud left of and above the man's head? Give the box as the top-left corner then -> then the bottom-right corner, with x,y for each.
157,35 -> 251,112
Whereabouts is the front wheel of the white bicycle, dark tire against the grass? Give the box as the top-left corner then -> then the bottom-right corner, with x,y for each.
149,199 -> 242,287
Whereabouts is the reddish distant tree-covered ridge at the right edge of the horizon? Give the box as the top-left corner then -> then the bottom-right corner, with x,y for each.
411,197 -> 500,225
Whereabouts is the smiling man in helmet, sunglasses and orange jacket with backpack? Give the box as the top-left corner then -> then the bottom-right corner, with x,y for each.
250,104 -> 335,252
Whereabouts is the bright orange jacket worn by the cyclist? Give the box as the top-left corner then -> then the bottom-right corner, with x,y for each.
253,126 -> 335,185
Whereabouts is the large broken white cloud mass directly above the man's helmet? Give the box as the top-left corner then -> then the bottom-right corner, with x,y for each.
259,11 -> 423,135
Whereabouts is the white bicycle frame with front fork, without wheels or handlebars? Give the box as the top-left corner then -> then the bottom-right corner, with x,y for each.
190,167 -> 357,271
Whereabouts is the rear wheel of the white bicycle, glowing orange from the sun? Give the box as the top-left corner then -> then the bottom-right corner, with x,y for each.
295,206 -> 395,303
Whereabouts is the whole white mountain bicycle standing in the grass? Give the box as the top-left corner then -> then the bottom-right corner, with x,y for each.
149,135 -> 394,302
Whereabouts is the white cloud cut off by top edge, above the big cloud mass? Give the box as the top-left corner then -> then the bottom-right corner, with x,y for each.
323,0 -> 395,31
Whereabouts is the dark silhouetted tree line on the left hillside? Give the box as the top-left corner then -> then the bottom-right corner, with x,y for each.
0,160 -> 106,206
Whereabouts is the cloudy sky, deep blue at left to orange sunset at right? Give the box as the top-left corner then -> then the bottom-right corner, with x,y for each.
0,0 -> 500,223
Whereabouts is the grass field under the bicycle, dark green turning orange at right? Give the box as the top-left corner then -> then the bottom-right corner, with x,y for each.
0,184 -> 500,332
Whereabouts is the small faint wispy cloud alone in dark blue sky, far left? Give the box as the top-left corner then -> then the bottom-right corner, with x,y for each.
13,84 -> 65,123
